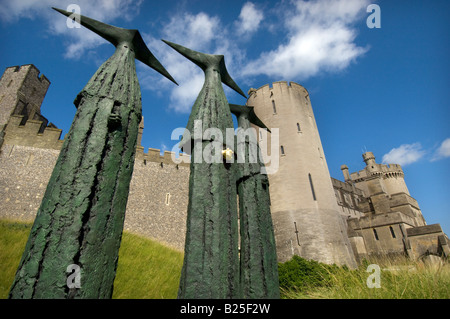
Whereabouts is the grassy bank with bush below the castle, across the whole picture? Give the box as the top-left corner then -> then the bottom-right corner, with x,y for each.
0,220 -> 450,299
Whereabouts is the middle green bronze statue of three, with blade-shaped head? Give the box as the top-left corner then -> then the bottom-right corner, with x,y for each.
163,40 -> 245,298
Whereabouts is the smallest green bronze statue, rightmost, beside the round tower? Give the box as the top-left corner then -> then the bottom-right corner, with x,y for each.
230,104 -> 280,299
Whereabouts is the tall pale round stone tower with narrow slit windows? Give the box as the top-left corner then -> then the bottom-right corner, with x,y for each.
247,81 -> 356,267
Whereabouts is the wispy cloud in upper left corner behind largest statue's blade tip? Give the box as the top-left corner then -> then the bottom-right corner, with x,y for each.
0,0 -> 142,59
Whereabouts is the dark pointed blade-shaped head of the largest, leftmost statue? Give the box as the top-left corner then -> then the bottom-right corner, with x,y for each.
52,7 -> 178,85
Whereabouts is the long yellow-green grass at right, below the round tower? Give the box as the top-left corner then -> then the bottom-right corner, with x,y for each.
280,258 -> 450,299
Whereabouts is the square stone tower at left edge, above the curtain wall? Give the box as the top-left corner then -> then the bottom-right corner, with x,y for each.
0,64 -> 50,128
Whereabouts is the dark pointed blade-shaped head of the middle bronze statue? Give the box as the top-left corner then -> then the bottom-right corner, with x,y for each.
162,40 -> 247,98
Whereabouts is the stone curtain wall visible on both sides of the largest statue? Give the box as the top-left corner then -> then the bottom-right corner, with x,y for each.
0,144 -> 189,250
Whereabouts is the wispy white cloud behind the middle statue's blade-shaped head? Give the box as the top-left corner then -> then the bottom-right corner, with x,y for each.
138,12 -> 246,113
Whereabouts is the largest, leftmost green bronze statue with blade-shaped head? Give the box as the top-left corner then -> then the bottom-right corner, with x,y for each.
9,8 -> 175,299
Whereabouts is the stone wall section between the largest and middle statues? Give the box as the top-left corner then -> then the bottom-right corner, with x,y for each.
124,159 -> 189,250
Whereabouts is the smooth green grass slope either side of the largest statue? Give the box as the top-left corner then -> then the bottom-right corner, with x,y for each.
0,220 -> 183,299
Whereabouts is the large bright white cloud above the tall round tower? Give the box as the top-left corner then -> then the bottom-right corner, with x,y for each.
243,0 -> 369,80
